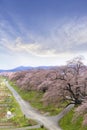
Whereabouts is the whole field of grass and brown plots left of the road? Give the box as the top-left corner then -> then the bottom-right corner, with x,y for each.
0,79 -> 36,127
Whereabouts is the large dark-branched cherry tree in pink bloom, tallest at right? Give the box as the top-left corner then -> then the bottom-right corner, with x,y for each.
53,57 -> 87,104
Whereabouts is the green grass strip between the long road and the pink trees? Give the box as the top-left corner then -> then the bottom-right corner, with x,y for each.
9,81 -> 63,115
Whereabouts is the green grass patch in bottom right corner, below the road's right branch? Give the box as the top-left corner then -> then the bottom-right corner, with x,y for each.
59,109 -> 87,130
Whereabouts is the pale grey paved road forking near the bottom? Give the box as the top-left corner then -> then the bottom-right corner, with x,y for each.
5,81 -> 73,130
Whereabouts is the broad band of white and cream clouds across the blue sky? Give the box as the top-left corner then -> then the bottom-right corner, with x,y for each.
0,18 -> 87,57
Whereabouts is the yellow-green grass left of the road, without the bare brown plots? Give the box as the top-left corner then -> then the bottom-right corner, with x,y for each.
0,79 -> 36,127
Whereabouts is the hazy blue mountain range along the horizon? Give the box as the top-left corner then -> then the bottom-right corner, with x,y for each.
0,66 -> 53,73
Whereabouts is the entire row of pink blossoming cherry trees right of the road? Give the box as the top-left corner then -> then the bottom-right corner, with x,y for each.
4,57 -> 87,125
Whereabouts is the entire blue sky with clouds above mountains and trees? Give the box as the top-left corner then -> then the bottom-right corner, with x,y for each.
0,0 -> 87,69
